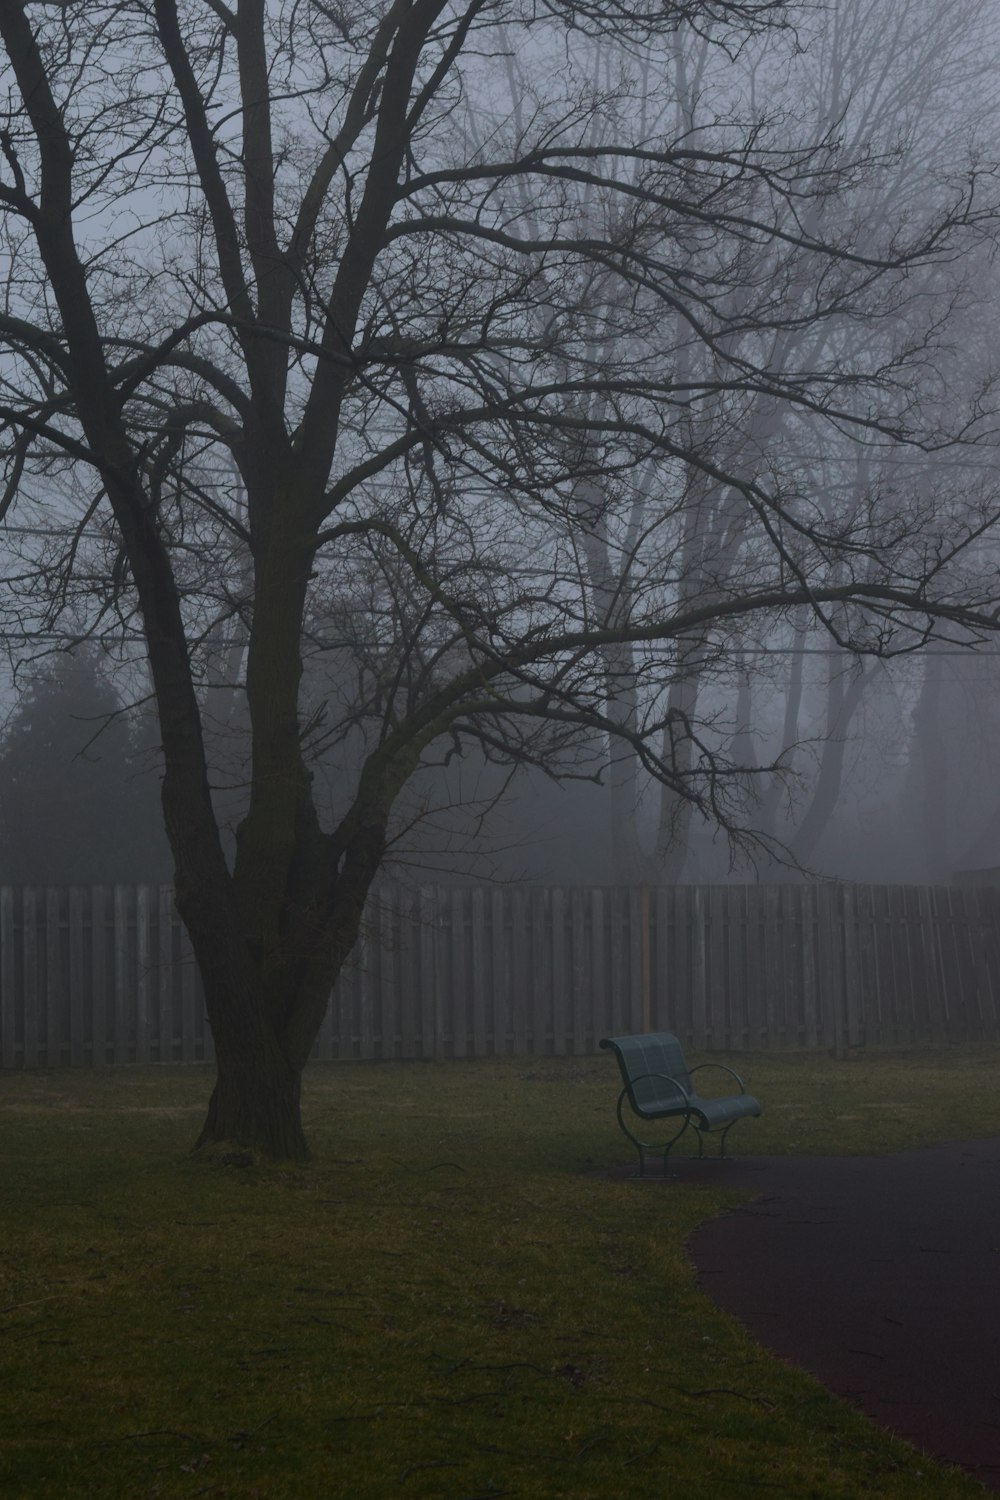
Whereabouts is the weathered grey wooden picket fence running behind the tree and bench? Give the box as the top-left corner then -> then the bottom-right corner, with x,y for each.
0,884 -> 1000,1068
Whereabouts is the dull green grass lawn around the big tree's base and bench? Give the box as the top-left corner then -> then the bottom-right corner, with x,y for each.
0,1050 -> 1000,1500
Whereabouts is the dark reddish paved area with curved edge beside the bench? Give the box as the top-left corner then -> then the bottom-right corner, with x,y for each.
616,1140 -> 1000,1491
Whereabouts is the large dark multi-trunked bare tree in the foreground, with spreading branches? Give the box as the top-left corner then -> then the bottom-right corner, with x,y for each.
0,0 -> 994,1157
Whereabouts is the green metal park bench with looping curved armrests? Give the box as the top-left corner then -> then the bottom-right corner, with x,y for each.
601,1032 -> 760,1176
